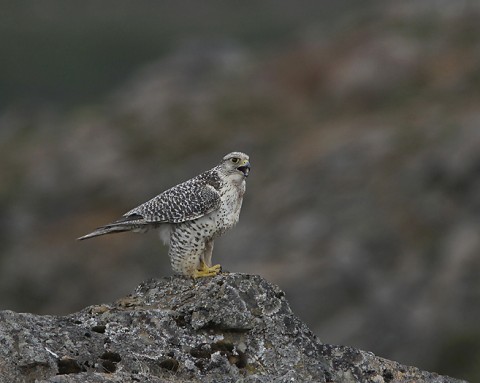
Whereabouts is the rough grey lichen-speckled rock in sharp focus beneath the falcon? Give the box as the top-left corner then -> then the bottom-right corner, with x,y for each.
0,274 -> 460,383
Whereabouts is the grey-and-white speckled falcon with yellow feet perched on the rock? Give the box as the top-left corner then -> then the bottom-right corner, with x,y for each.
79,152 -> 250,277
